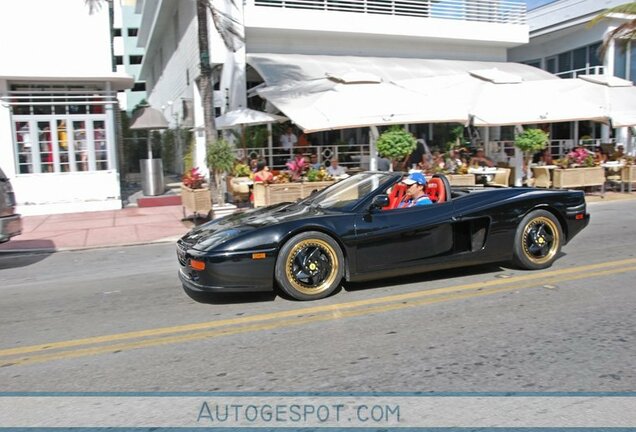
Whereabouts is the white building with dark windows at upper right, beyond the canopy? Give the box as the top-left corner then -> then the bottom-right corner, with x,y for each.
508,0 -> 636,143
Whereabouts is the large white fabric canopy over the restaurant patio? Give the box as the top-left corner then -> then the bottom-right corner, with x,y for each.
248,54 -> 636,132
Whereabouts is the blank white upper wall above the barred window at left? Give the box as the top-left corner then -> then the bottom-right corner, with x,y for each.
0,0 -> 111,76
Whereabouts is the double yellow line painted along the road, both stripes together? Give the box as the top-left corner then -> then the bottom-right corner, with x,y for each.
0,259 -> 636,367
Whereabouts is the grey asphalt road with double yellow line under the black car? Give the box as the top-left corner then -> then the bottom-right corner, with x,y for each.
0,201 -> 636,392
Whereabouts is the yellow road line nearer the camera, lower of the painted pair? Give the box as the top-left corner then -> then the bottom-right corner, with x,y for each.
2,267 -> 636,366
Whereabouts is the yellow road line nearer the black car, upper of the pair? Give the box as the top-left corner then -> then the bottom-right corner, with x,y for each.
0,258 -> 636,357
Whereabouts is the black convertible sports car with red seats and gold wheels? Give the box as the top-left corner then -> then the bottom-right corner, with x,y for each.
177,172 -> 589,300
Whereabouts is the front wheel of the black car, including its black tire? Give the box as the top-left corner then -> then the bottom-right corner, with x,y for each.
275,231 -> 344,300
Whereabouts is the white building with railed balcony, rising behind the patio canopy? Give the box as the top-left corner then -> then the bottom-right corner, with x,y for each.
137,0 -> 528,171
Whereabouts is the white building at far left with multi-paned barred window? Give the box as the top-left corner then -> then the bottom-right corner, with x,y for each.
0,0 -> 132,215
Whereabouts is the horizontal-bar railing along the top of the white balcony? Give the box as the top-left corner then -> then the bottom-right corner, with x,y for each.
248,0 -> 526,24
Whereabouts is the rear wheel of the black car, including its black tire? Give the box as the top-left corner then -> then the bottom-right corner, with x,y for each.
513,210 -> 563,270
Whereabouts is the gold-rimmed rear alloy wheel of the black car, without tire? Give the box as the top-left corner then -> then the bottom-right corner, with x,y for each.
522,216 -> 561,265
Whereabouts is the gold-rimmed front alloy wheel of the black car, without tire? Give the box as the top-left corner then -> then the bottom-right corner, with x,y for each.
285,239 -> 340,295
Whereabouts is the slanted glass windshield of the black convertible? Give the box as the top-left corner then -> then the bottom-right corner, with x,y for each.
304,172 -> 395,209
